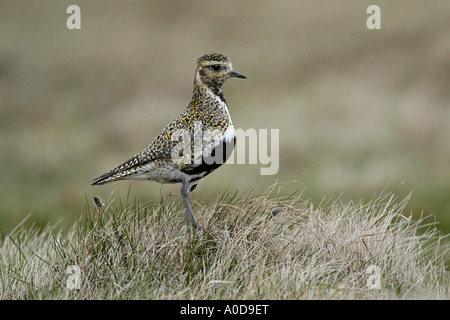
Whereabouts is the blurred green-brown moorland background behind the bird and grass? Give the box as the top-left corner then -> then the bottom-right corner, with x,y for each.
0,0 -> 450,236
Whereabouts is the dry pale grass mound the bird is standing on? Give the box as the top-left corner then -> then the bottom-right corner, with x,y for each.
0,184 -> 449,299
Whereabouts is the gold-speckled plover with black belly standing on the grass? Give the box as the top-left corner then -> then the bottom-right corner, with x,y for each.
91,53 -> 247,233
